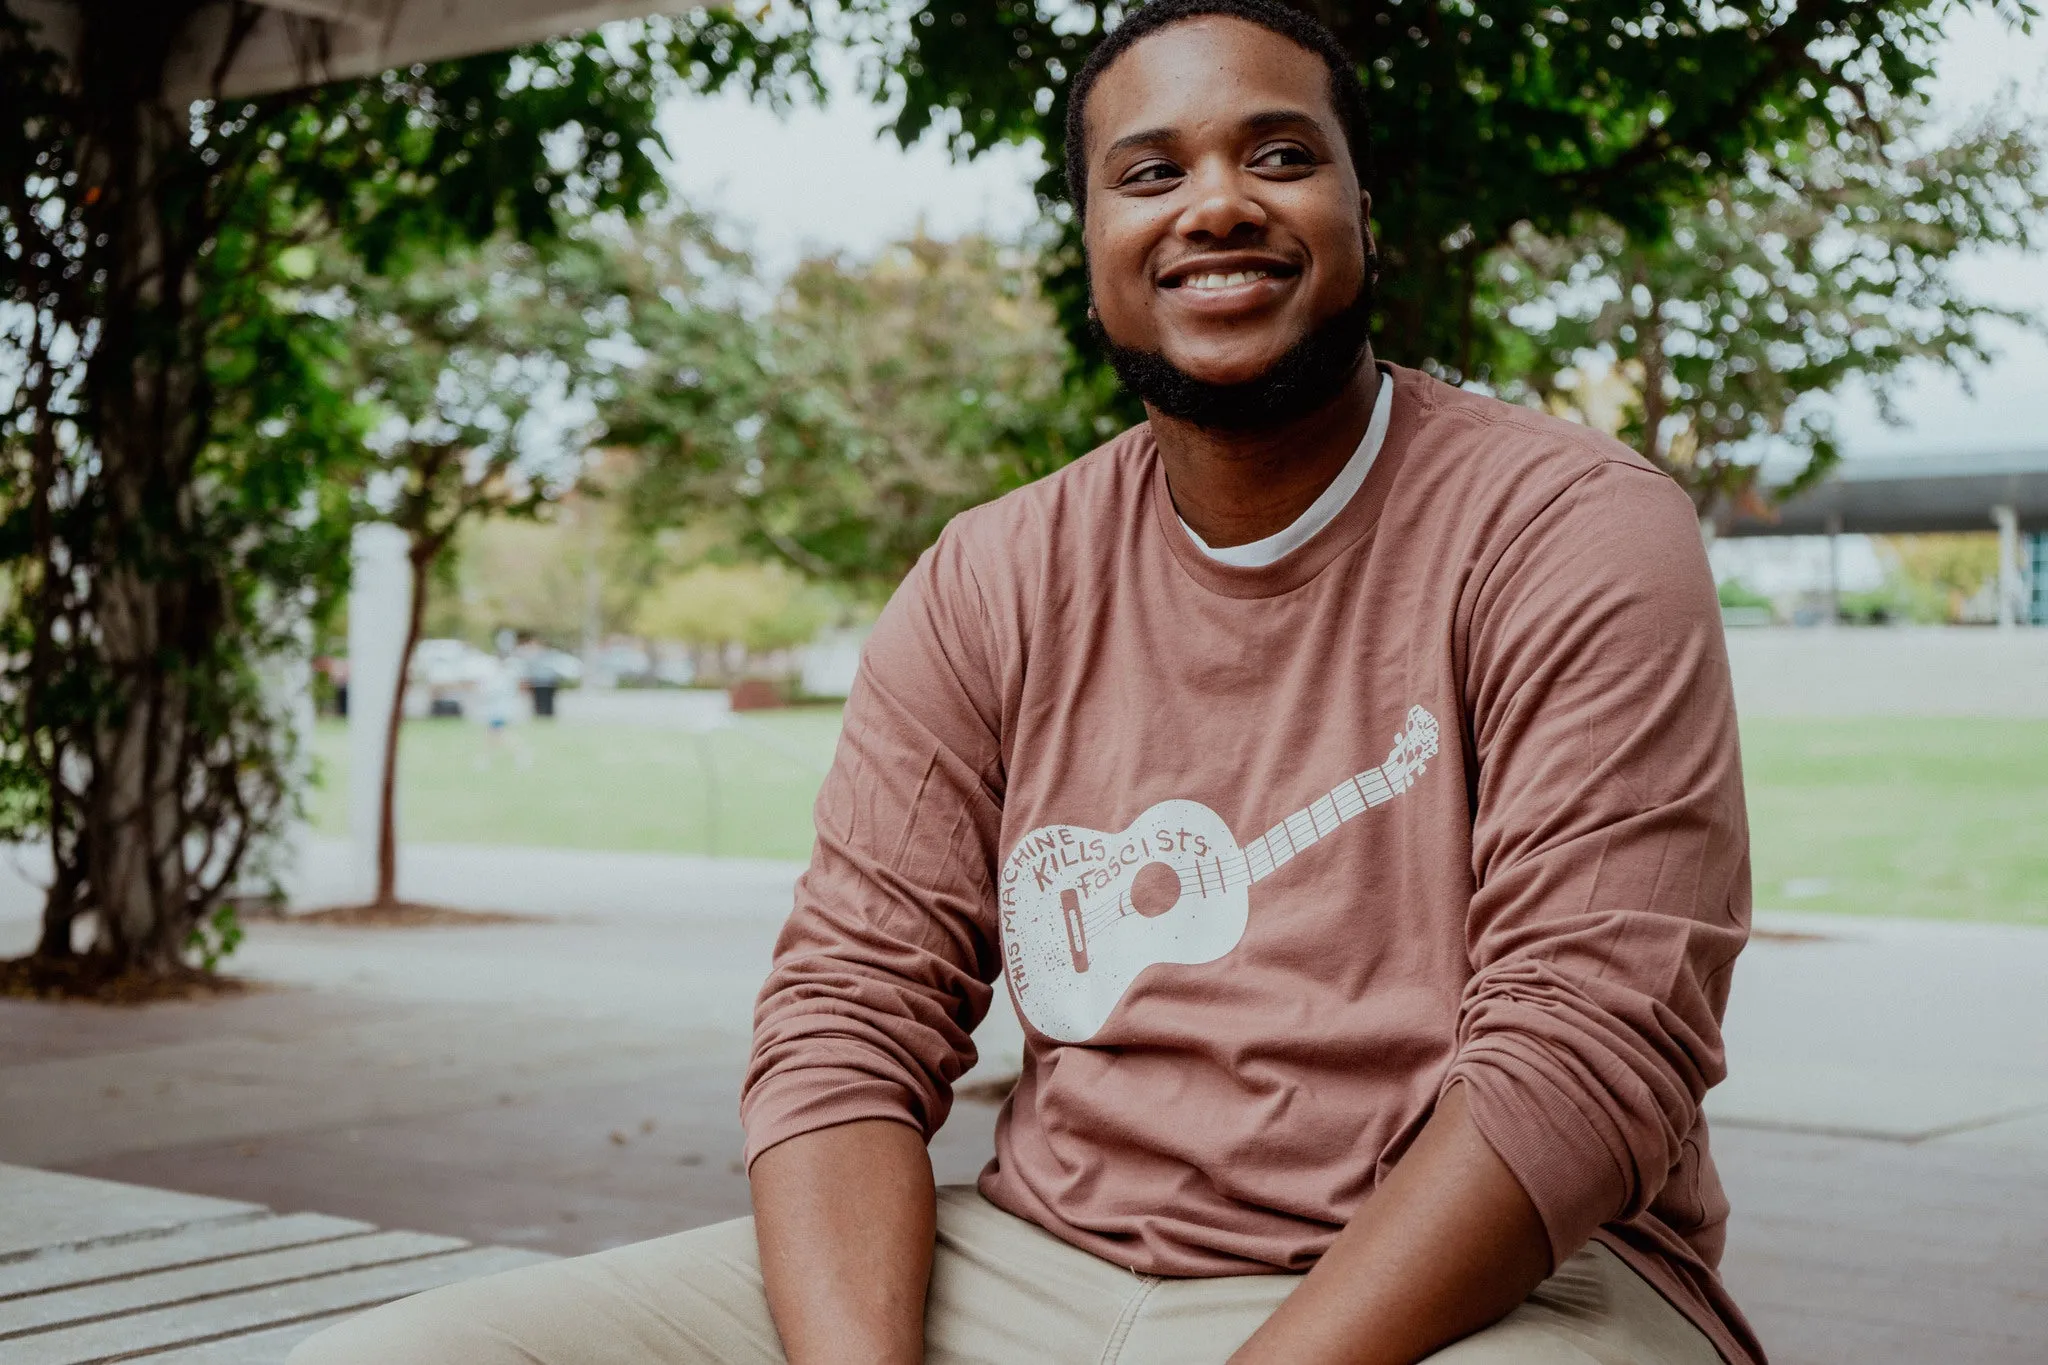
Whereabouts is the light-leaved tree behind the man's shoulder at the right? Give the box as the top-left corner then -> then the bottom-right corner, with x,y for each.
1483,100 -> 2048,518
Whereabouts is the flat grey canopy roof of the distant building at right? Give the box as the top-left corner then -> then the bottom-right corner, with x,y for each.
1722,450 -> 2048,536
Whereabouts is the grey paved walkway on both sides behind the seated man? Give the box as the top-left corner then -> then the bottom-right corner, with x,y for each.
0,849 -> 2048,1365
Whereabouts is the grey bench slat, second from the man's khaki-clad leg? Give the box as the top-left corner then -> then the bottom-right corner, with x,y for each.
0,1232 -> 469,1351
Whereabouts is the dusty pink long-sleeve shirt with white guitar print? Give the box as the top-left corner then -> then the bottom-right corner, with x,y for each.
741,368 -> 1763,1363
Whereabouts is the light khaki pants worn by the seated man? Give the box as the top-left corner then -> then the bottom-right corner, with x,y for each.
291,1187 -> 1720,1365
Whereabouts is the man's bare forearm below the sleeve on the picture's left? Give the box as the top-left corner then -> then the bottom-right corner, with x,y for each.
752,1119 -> 938,1365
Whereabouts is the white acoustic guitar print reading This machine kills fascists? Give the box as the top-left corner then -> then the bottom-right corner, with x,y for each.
997,706 -> 1438,1042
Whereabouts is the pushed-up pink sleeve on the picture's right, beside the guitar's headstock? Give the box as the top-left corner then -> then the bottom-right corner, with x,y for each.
1446,460 -> 1749,1263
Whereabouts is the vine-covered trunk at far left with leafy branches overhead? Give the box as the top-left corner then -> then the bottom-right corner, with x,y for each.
0,10 -> 807,978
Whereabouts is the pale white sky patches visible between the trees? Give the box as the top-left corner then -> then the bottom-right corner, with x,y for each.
664,14 -> 2048,472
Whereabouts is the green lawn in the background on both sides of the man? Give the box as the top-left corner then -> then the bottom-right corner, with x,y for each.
313,708 -> 2048,925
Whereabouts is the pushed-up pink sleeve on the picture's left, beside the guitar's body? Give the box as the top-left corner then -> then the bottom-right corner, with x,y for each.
739,532 -> 1001,1166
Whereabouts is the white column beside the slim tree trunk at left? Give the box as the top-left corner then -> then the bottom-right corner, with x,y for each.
348,522 -> 412,900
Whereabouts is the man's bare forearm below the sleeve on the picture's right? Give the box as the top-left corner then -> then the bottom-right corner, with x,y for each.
1231,1085 -> 1550,1365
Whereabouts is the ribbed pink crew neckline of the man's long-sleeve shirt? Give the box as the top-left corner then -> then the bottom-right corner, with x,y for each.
1145,364 -> 1432,598
